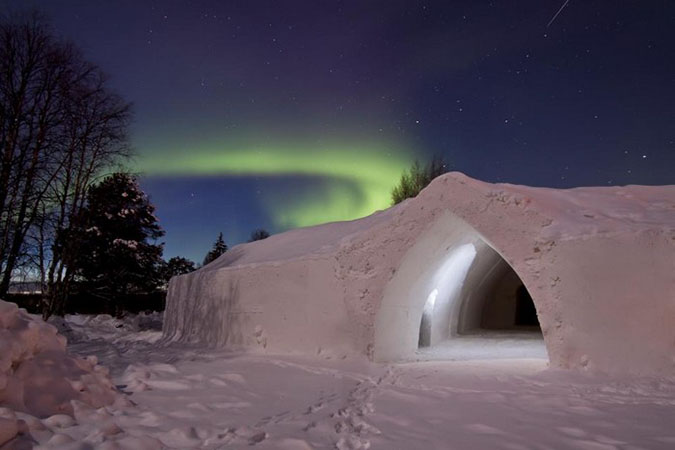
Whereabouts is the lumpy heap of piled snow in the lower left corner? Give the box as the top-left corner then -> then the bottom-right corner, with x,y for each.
0,301 -> 119,446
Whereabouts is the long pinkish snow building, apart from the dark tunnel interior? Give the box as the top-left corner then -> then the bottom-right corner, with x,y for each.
164,172 -> 675,374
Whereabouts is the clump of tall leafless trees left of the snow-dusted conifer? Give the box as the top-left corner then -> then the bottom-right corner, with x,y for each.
0,14 -> 130,315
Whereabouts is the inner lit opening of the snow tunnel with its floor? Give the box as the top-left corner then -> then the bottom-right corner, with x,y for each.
417,241 -> 547,359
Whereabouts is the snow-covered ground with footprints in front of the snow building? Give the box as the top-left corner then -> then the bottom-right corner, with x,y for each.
2,316 -> 675,450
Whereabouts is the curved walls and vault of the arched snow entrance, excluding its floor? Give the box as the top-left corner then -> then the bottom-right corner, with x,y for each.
374,212 -> 540,361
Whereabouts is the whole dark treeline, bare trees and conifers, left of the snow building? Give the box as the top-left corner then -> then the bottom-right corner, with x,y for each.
0,13 -> 284,317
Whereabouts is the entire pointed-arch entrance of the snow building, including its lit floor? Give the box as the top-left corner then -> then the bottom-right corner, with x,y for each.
375,213 -> 548,360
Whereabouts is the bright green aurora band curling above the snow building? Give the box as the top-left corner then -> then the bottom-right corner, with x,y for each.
137,143 -> 412,229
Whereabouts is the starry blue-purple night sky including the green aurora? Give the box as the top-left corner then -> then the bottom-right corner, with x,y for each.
0,0 -> 675,261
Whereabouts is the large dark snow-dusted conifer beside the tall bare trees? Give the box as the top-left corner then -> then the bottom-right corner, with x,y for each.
70,173 -> 164,314
